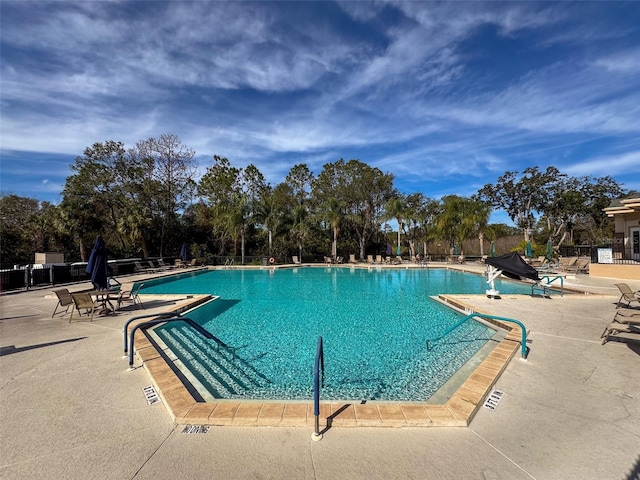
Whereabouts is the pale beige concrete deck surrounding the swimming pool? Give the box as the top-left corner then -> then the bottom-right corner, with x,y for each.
0,265 -> 640,479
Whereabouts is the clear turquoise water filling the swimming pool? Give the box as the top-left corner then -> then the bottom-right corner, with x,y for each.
142,268 -> 530,401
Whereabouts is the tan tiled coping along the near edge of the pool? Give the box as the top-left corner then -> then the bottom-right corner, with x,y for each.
136,295 -> 521,428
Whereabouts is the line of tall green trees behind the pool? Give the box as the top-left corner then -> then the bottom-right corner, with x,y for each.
0,134 -> 629,265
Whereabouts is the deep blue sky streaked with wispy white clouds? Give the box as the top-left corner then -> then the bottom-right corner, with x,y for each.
0,0 -> 640,225
